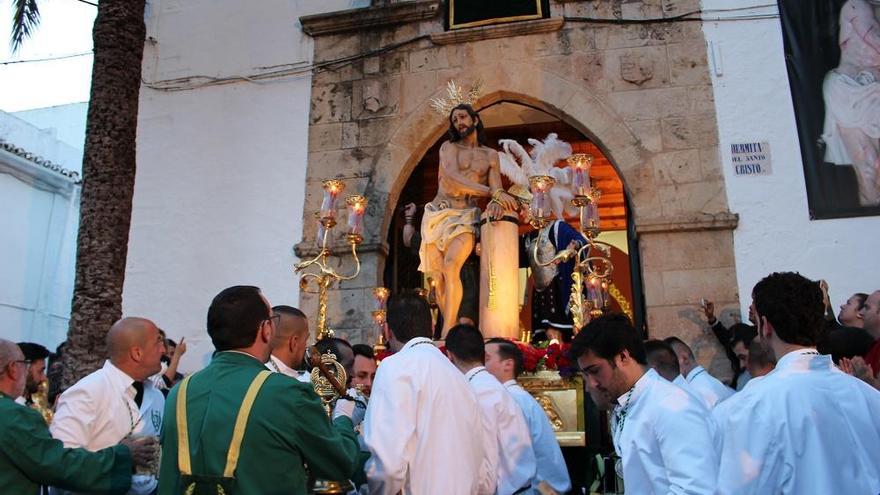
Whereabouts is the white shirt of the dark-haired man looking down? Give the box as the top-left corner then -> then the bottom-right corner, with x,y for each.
611,369 -> 718,495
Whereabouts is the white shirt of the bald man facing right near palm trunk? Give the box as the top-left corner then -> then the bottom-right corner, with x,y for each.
49,361 -> 165,495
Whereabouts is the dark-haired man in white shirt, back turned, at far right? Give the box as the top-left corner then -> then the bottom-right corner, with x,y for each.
718,273 -> 880,495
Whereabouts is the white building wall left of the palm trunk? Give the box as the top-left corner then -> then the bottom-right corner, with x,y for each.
0,112 -> 82,349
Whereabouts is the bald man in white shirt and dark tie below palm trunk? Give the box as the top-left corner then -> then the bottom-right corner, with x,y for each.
49,318 -> 165,495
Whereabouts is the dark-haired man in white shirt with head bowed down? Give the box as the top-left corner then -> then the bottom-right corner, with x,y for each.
571,314 -> 718,495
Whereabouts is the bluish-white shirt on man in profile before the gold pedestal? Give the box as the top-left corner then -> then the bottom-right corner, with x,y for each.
504,380 -> 571,493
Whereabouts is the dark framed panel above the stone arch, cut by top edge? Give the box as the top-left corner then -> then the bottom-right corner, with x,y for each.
446,0 -> 550,29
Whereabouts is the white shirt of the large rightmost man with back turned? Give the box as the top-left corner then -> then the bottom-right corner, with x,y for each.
718,349 -> 880,495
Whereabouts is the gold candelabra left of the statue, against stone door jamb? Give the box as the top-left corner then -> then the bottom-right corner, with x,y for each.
294,179 -> 367,340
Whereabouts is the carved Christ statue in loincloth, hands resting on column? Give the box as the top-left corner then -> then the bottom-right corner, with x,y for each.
419,106 -> 516,338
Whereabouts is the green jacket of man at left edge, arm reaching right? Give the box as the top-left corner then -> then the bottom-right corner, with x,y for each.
0,393 -> 132,495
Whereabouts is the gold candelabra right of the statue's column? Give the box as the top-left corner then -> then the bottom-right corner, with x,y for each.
529,153 -> 615,333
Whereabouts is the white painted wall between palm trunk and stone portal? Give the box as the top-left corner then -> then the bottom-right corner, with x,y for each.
123,0 -> 369,371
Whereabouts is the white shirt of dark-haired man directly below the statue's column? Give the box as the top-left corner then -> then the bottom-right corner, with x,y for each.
465,366 -> 537,495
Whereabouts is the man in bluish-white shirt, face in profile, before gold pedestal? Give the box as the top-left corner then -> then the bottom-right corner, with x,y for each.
486,338 -> 571,493
